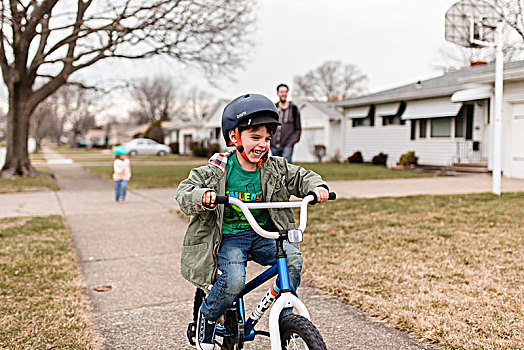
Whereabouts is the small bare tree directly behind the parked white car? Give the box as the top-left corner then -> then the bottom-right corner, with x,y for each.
129,76 -> 181,124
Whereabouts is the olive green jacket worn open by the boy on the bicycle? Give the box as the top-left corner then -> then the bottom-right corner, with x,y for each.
175,150 -> 327,293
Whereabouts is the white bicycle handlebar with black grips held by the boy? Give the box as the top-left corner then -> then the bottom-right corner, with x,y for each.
215,192 -> 337,239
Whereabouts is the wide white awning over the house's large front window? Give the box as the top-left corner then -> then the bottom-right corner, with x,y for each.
401,97 -> 462,120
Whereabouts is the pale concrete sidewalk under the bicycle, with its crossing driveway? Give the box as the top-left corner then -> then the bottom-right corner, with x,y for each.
0,150 -> 524,349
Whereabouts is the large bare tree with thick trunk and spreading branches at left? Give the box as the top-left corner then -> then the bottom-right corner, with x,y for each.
0,0 -> 254,177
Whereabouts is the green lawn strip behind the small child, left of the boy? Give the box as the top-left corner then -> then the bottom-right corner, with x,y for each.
85,164 -> 201,188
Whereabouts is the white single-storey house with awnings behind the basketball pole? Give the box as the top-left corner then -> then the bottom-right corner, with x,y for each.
337,61 -> 524,178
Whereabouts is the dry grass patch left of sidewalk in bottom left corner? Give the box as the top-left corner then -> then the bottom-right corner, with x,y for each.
0,216 -> 94,349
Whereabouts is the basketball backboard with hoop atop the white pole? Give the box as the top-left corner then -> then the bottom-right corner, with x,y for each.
445,0 -> 500,47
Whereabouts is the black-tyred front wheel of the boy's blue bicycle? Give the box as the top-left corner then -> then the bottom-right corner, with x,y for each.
280,314 -> 327,350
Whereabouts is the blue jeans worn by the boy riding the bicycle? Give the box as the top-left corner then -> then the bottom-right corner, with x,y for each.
200,231 -> 302,321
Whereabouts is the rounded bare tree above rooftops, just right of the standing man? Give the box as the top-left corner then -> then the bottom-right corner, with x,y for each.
293,61 -> 367,101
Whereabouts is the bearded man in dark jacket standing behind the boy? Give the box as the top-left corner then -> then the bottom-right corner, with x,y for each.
271,84 -> 302,163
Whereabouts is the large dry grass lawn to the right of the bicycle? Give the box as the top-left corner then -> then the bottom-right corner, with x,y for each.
302,193 -> 524,349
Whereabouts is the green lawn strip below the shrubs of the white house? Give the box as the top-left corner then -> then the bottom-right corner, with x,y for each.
297,163 -> 431,181
